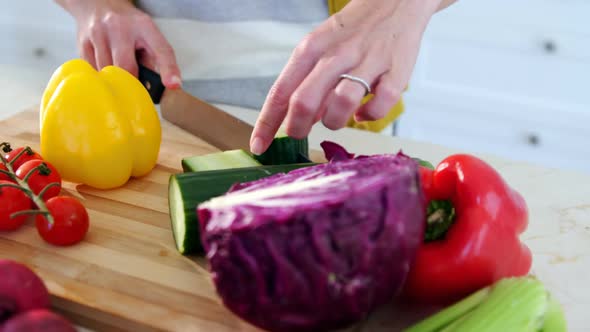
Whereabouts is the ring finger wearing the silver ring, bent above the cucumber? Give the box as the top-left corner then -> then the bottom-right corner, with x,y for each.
322,58 -> 385,130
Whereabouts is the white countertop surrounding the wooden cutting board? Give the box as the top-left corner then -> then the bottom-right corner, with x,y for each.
0,65 -> 590,331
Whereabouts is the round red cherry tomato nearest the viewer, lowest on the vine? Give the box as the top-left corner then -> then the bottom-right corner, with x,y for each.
35,196 -> 89,246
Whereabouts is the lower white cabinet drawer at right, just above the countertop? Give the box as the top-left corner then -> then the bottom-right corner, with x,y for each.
398,100 -> 590,172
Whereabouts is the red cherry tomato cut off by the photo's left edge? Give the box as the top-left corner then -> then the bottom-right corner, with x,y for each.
0,181 -> 31,231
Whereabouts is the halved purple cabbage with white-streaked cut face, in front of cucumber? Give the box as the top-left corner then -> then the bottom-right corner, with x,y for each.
198,153 -> 425,331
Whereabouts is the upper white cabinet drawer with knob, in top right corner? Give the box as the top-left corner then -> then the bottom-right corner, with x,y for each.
417,0 -> 590,105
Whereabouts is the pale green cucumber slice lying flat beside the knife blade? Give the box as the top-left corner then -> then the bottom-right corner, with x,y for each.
182,150 -> 261,172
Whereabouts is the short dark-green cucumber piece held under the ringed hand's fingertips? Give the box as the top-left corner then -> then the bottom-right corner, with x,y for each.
254,130 -> 309,165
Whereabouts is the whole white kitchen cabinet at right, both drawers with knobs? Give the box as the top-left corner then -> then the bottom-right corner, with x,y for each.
397,0 -> 590,172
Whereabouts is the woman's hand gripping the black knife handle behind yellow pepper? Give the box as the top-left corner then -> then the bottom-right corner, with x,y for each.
56,0 -> 181,88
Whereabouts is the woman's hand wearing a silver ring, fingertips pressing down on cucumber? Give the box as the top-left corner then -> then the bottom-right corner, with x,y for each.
250,0 -> 452,154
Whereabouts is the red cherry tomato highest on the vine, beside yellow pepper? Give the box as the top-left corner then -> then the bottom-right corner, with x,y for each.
16,160 -> 61,201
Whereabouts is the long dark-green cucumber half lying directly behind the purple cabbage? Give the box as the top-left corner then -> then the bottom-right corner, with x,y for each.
168,163 -> 315,255
